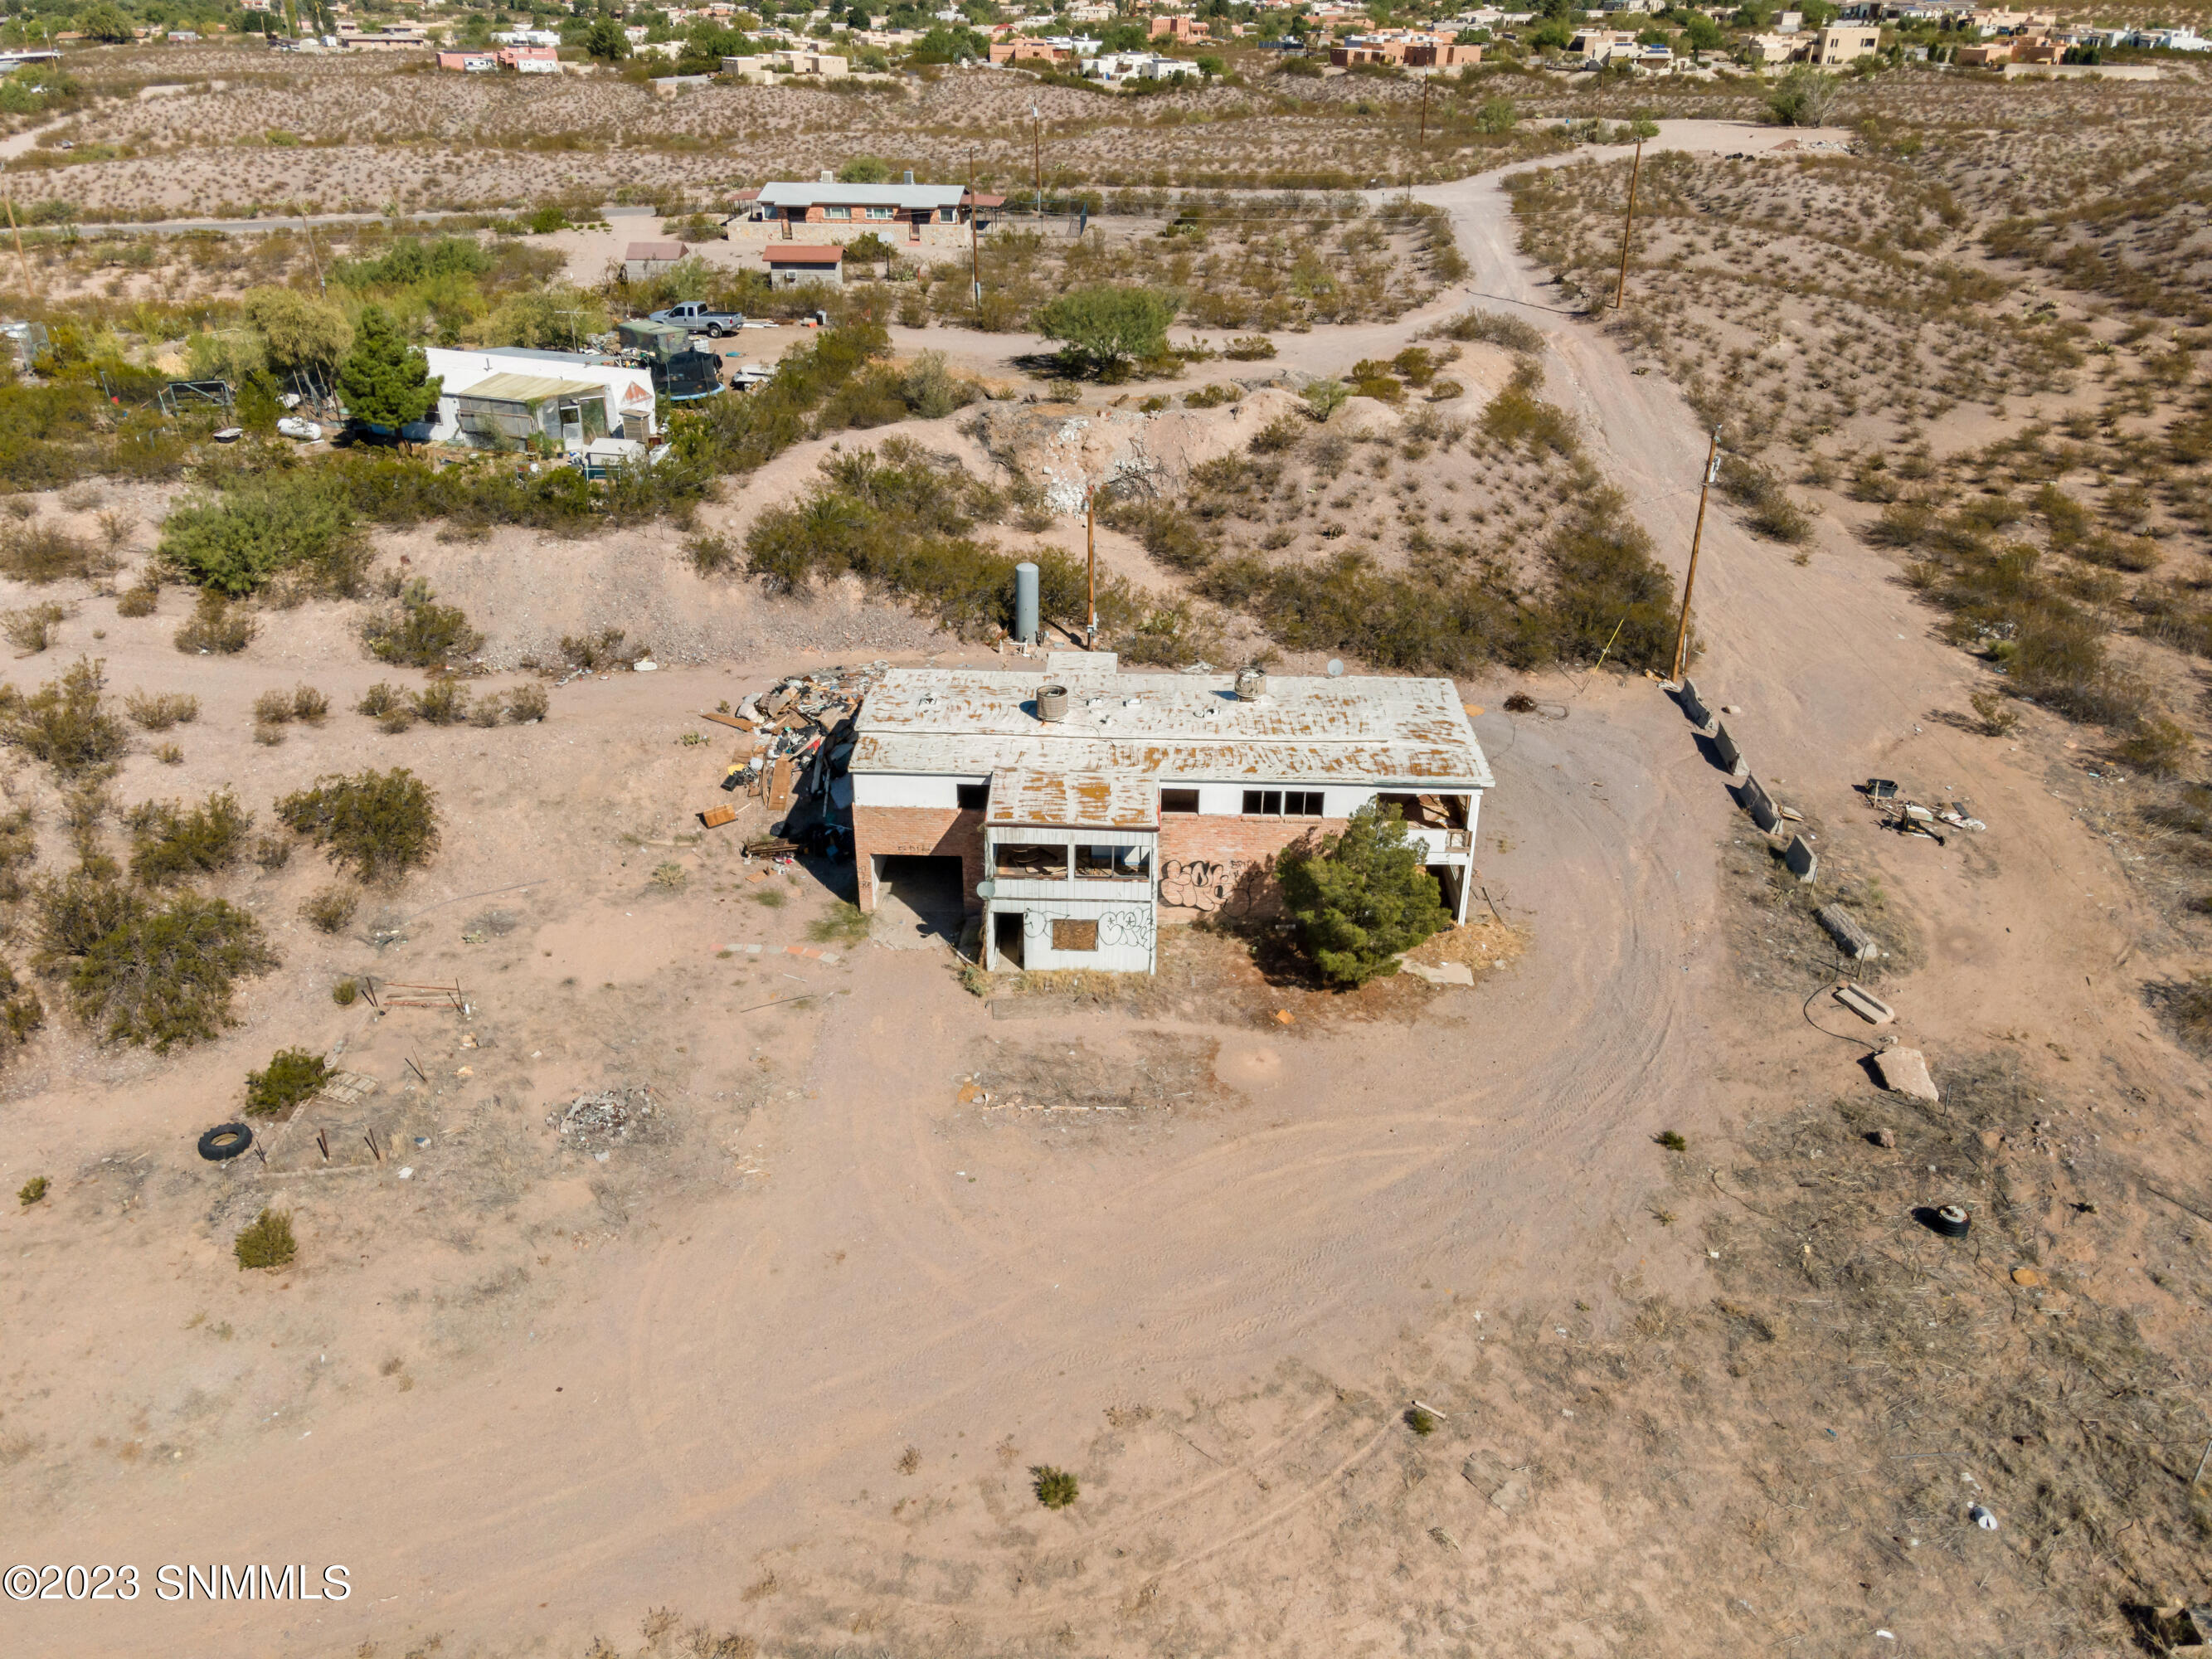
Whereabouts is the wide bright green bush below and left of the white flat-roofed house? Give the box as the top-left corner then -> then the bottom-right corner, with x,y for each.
159,471 -> 369,600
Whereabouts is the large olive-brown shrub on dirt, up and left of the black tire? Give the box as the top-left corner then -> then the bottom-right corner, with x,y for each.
69,892 -> 276,1053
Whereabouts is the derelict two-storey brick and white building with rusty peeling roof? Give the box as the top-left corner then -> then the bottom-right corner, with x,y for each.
847,650 -> 1491,973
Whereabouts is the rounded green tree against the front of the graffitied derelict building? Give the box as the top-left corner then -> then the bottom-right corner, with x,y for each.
1276,803 -> 1451,986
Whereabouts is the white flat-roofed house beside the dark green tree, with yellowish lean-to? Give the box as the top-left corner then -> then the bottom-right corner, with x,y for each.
425,345 -> 659,451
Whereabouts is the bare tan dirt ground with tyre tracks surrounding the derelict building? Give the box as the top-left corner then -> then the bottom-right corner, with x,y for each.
0,119 -> 2208,1655
